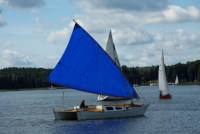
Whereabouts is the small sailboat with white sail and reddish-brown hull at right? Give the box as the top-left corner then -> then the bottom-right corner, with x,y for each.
158,50 -> 171,99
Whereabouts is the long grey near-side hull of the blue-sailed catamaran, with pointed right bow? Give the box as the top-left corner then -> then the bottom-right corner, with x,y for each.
77,104 -> 149,120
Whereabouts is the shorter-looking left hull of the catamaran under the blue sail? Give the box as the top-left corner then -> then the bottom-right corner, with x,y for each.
53,109 -> 77,120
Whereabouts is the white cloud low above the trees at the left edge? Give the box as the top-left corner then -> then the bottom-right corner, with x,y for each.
0,50 -> 33,68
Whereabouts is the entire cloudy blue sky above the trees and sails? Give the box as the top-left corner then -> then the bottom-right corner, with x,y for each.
0,0 -> 200,69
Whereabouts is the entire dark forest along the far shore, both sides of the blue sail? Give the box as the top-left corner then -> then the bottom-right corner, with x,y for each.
0,60 -> 200,90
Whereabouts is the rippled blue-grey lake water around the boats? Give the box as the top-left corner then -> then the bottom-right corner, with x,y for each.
0,86 -> 200,134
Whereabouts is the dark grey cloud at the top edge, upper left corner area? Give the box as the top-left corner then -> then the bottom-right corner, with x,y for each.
8,0 -> 45,8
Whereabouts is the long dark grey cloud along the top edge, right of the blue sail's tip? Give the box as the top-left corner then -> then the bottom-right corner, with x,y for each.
73,0 -> 168,12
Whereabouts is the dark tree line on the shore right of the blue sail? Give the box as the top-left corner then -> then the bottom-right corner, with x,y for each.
122,60 -> 200,85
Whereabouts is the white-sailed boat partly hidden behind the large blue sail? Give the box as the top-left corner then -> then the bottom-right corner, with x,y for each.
97,30 -> 128,101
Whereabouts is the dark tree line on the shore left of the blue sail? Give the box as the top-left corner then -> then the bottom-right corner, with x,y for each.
0,67 -> 51,89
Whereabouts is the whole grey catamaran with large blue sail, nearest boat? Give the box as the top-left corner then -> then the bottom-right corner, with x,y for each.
49,21 -> 149,120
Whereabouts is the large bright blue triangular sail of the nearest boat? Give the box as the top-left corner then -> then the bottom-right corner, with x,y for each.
49,23 -> 138,98
